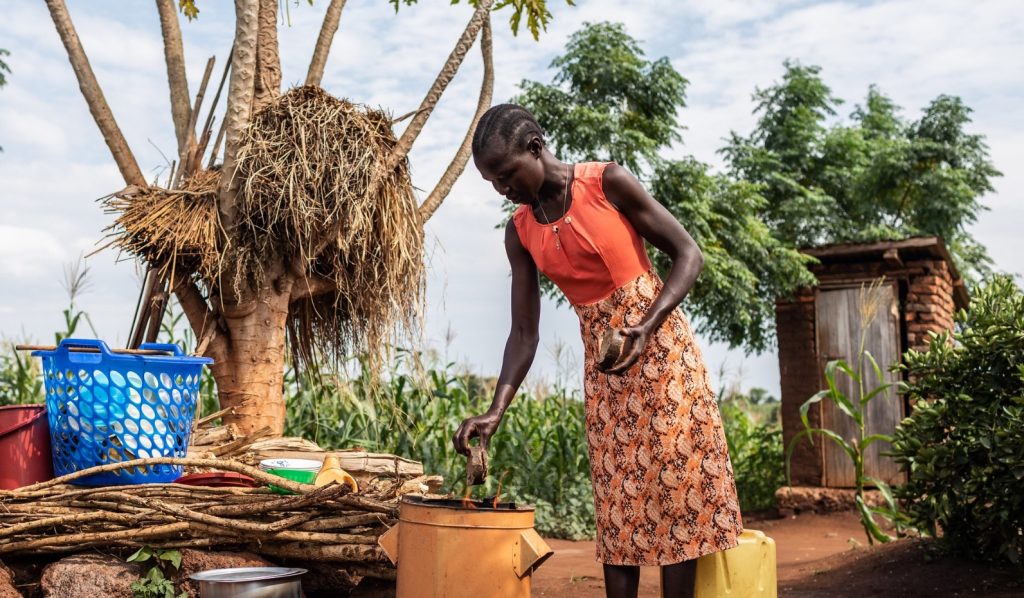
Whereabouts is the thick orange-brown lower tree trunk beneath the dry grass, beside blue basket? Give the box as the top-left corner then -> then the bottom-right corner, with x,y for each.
211,282 -> 292,436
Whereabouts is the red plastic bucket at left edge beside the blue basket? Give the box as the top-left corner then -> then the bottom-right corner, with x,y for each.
0,404 -> 53,490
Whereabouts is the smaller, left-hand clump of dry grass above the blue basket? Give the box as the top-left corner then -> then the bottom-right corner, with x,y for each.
103,170 -> 221,281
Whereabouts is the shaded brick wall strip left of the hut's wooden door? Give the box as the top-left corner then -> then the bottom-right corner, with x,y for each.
775,289 -> 822,485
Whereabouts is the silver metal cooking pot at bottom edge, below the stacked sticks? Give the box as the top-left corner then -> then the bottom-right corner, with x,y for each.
188,567 -> 306,598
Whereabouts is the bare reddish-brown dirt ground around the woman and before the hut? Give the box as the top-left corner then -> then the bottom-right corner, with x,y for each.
532,512 -> 1024,598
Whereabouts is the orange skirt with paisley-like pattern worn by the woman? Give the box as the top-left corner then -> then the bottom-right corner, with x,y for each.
573,272 -> 742,565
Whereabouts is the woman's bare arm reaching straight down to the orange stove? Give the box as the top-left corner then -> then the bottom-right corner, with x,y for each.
452,220 -> 541,455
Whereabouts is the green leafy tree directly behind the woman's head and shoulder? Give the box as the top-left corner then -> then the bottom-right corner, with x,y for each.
512,23 -> 813,351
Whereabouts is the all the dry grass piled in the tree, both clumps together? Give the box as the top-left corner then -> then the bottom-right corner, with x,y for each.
106,86 -> 424,368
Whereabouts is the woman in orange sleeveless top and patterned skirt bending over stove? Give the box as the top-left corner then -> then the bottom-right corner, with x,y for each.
454,104 -> 742,598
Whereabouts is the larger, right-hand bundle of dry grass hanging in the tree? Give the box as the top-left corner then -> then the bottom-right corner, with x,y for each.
237,86 -> 424,359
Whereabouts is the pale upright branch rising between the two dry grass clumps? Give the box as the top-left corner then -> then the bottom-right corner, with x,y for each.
217,0 -> 259,238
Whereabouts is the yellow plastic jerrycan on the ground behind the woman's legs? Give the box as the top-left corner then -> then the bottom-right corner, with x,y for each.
694,529 -> 778,598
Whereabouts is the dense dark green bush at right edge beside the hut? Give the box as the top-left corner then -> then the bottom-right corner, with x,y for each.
893,277 -> 1024,563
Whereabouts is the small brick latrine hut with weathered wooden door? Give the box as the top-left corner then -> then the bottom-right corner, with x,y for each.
775,237 -> 968,487
